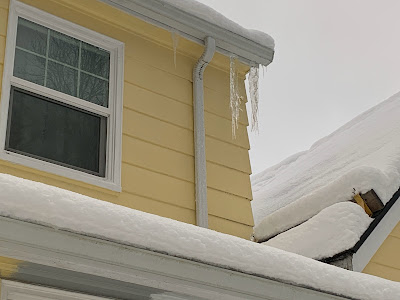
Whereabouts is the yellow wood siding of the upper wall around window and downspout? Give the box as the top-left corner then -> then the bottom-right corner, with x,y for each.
0,0 -> 253,239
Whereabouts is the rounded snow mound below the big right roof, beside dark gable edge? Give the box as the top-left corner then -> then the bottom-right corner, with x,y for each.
263,202 -> 372,259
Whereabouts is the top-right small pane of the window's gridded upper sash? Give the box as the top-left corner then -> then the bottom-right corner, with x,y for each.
81,43 -> 110,79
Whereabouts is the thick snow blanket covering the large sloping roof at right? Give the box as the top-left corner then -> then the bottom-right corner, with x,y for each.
252,93 -> 400,240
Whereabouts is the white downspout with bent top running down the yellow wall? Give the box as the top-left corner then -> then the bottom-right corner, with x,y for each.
193,36 -> 215,228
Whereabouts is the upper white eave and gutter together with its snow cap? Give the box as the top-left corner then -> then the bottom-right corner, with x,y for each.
102,0 -> 275,65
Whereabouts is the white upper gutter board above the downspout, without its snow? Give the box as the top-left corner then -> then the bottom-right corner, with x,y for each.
101,0 -> 274,66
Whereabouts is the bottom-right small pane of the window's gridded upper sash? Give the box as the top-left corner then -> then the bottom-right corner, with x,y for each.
79,73 -> 108,107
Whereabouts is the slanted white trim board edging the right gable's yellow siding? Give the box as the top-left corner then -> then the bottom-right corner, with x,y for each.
353,200 -> 400,272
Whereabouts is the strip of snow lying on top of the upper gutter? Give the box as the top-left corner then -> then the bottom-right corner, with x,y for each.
160,0 -> 275,49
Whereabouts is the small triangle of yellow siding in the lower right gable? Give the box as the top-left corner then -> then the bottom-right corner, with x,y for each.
363,222 -> 400,282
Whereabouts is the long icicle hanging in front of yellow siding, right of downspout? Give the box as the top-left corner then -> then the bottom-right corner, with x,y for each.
229,55 -> 242,139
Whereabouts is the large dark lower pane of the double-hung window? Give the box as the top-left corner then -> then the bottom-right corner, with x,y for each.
6,88 -> 106,177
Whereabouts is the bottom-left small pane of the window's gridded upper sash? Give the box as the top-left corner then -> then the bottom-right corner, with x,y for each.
14,49 -> 46,85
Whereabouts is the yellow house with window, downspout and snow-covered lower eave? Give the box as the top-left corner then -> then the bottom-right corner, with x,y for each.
0,0 -> 400,300
